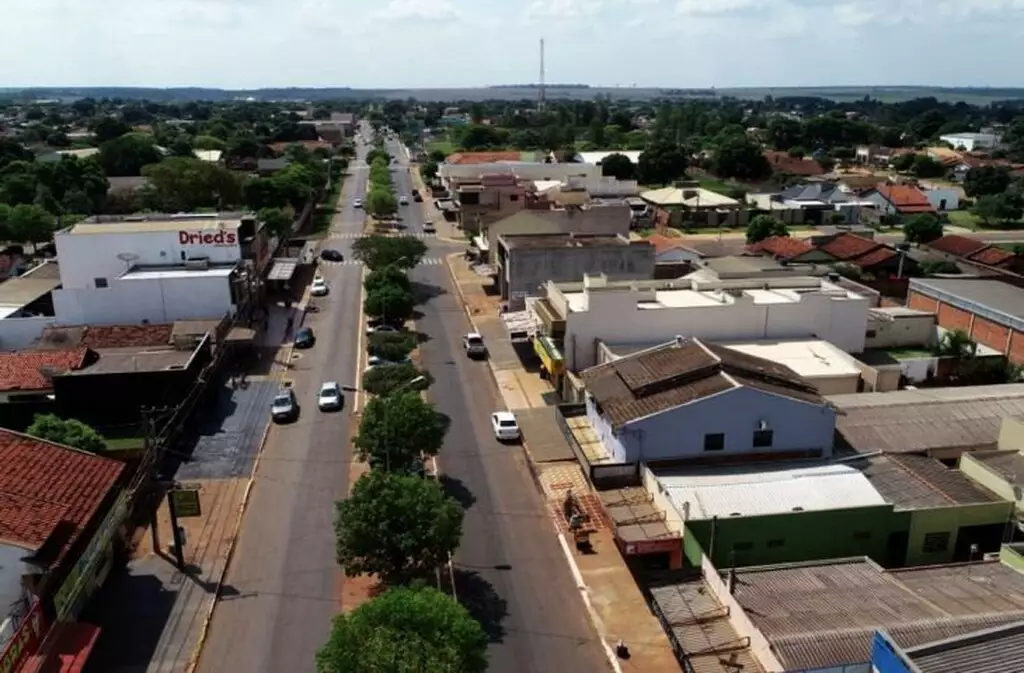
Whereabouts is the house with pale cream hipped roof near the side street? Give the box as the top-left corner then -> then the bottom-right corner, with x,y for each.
640,181 -> 746,227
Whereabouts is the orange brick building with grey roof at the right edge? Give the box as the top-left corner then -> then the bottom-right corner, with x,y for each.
906,279 -> 1024,364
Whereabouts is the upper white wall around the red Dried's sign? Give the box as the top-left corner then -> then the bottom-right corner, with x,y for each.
53,228 -> 242,290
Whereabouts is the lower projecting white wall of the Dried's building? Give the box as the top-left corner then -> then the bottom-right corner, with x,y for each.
53,277 -> 234,325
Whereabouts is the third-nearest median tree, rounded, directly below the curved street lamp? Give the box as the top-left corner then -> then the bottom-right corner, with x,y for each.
352,391 -> 449,470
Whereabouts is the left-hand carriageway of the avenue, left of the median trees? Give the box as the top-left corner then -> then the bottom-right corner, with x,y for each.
192,124 -> 368,673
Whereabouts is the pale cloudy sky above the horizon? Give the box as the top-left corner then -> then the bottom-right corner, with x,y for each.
6,0 -> 1024,88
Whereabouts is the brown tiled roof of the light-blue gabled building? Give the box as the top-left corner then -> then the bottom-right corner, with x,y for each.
583,339 -> 822,428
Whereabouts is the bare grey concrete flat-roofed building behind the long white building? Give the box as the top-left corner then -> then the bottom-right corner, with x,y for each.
496,234 -> 654,300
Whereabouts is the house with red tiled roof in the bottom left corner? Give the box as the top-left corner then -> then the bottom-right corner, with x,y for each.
0,428 -> 128,671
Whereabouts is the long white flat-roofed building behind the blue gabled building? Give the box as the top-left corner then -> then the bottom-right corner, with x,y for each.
531,269 -> 870,371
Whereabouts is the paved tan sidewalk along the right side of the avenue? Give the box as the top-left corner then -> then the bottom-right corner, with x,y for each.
447,254 -> 680,673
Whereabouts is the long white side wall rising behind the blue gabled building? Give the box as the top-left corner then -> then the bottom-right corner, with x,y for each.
564,290 -> 869,371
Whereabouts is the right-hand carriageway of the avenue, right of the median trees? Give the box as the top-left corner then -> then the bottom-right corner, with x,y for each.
389,138 -> 608,673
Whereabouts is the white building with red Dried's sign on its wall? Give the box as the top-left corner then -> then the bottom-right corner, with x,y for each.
53,215 -> 252,325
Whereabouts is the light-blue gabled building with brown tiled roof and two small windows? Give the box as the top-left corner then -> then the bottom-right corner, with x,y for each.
581,337 -> 836,464
